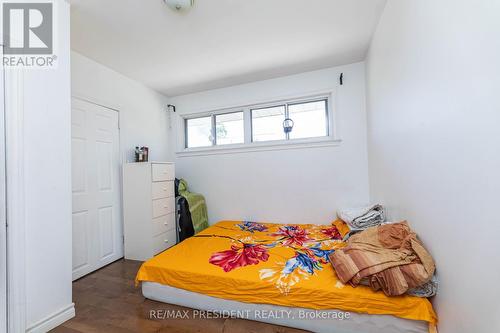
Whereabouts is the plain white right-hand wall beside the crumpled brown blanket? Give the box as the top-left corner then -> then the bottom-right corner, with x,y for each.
367,0 -> 500,333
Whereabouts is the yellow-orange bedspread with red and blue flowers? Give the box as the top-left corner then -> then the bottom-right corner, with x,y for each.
136,221 -> 437,324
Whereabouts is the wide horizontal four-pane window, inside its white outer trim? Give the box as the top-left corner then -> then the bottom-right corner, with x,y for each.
184,97 -> 331,148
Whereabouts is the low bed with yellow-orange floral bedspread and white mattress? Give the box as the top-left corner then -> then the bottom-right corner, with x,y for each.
136,221 -> 437,333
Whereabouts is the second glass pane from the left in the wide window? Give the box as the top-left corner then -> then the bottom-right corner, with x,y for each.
215,111 -> 245,145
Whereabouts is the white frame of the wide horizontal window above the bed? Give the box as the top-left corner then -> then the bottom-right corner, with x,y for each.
176,91 -> 341,156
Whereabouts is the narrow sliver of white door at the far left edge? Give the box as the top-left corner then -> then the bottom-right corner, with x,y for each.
0,44 -> 7,333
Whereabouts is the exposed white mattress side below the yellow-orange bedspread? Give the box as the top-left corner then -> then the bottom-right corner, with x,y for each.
142,282 -> 428,333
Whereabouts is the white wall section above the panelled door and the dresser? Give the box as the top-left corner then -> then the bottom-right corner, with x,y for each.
71,51 -> 172,161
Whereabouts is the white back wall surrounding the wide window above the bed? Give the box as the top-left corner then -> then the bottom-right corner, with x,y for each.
171,63 -> 368,224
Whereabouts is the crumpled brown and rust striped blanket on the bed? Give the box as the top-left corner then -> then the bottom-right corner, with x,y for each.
330,221 -> 435,296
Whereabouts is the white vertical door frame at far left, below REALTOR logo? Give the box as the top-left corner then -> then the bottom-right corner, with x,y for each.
4,59 -> 26,332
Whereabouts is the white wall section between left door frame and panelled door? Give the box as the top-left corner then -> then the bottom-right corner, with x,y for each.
22,1 -> 73,328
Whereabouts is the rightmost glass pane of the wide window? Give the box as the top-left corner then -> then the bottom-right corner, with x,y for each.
288,100 -> 328,139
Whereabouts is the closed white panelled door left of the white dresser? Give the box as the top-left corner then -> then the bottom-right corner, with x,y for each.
71,98 -> 123,280
